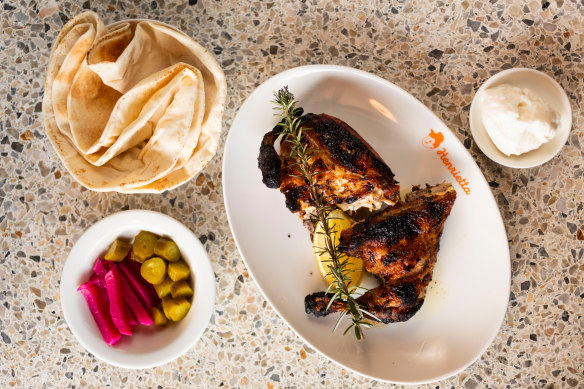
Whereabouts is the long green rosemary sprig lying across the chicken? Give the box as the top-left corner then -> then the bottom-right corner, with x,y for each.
273,86 -> 378,340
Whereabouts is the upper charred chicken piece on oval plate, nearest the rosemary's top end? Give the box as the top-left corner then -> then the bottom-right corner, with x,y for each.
258,113 -> 399,224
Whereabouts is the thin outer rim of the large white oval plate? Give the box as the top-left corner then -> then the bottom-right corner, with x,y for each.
221,64 -> 512,385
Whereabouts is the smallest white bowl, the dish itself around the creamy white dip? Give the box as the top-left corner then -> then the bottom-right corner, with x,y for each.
469,68 -> 572,168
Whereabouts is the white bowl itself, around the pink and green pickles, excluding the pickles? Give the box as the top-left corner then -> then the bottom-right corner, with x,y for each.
61,210 -> 215,369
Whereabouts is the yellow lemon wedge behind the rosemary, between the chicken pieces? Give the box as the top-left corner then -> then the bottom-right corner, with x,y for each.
312,209 -> 363,288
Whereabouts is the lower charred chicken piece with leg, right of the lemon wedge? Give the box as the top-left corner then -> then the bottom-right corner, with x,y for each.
304,184 -> 456,323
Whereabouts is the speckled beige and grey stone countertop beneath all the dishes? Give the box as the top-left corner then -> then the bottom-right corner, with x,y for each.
0,0 -> 584,389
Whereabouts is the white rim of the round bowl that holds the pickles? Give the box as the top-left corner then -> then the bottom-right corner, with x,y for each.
59,209 -> 217,370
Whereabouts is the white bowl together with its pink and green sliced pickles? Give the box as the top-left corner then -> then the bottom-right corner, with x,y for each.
60,210 -> 215,368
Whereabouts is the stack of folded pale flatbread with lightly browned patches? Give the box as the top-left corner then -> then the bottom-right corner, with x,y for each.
43,12 -> 227,193
